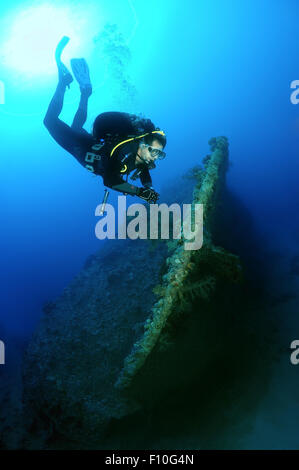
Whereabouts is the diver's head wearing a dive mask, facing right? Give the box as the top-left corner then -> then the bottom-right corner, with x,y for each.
136,133 -> 166,165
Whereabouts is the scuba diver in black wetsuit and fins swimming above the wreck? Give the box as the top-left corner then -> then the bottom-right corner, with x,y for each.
44,36 -> 166,203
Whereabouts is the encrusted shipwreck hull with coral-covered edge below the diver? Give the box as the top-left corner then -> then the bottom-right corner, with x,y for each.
23,137 -> 241,448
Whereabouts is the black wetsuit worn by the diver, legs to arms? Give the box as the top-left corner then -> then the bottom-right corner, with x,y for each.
44,98 -> 155,195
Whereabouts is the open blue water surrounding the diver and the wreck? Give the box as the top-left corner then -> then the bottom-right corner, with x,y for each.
0,0 -> 299,448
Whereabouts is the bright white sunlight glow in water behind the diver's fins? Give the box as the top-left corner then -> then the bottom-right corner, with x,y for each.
2,3 -> 99,77
